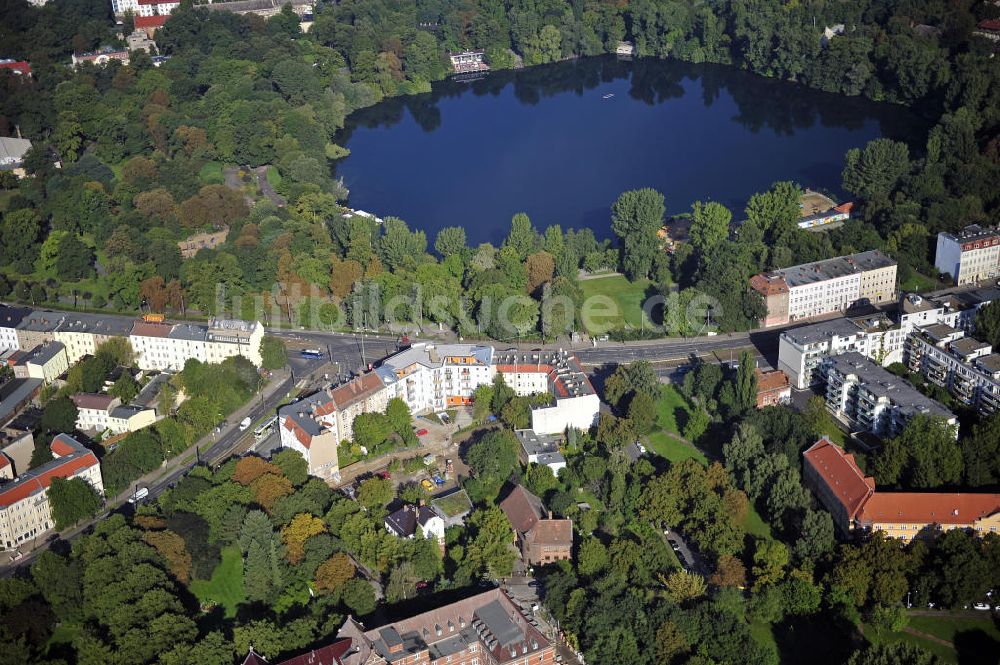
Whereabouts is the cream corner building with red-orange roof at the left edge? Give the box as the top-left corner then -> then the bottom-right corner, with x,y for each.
0,434 -> 104,549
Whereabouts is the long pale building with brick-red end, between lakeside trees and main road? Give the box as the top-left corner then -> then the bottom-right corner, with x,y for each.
750,250 -> 896,327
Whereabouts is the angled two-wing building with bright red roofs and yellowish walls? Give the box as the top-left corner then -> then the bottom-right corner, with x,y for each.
803,438 -> 1000,542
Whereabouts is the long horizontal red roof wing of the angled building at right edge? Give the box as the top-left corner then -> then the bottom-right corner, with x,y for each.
858,492 -> 1000,525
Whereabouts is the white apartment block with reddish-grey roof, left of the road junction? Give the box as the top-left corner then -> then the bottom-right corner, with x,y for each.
128,319 -> 264,372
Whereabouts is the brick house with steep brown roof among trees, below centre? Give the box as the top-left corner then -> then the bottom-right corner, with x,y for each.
500,485 -> 573,566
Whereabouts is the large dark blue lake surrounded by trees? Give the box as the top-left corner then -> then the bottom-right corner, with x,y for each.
335,56 -> 927,245
